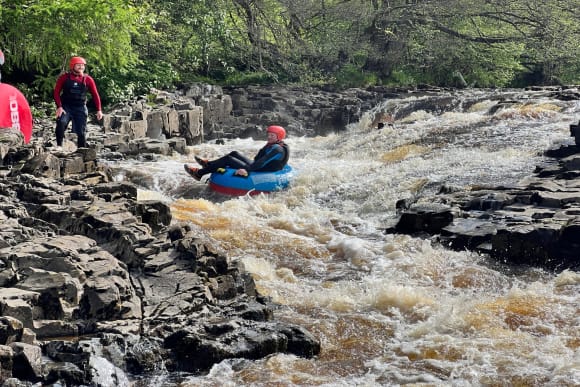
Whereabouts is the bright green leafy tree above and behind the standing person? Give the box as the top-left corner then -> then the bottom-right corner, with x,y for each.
0,0 -> 139,98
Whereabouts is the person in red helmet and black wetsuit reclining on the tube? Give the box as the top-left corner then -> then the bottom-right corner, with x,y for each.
183,125 -> 290,181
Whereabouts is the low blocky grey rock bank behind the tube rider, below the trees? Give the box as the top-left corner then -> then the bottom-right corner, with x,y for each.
103,84 -> 404,145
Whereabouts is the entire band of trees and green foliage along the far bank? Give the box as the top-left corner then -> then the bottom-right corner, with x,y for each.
0,0 -> 580,104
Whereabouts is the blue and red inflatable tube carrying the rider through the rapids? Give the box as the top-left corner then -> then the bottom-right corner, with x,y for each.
209,165 -> 294,196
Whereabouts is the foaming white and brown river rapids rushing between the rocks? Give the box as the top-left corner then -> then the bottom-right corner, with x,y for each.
110,90 -> 580,386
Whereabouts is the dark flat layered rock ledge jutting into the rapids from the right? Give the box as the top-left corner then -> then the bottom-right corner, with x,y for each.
387,123 -> 580,271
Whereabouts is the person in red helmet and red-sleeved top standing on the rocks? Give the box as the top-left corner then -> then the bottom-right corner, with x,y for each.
53,56 -> 103,148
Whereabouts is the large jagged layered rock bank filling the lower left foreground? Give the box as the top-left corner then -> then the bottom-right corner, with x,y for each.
0,146 -> 320,386
